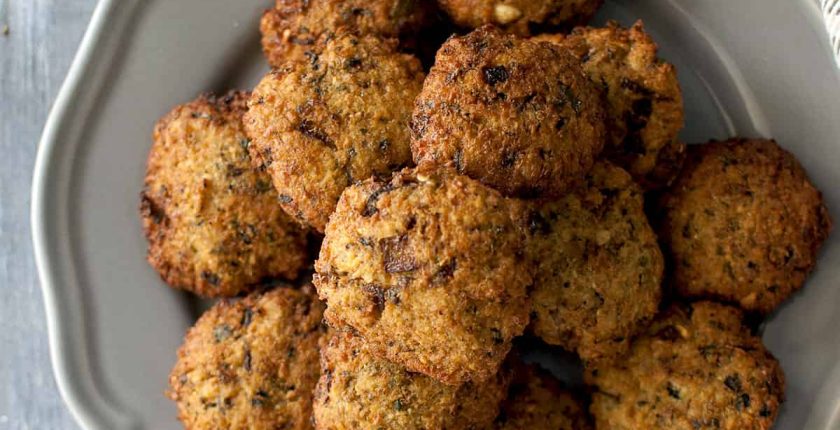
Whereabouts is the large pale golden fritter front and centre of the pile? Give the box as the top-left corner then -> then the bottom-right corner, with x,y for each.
314,168 -> 532,385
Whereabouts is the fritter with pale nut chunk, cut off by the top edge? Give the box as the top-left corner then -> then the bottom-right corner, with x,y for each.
438,0 -> 604,36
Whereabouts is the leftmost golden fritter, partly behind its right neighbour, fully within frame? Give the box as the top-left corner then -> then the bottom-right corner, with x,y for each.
141,92 -> 306,297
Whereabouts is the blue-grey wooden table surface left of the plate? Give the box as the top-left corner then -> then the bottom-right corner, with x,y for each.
0,0 -> 96,430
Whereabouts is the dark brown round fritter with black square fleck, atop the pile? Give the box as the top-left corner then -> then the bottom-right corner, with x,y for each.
411,27 -> 606,197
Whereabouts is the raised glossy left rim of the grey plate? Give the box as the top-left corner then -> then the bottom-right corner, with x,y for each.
30,0 -> 138,429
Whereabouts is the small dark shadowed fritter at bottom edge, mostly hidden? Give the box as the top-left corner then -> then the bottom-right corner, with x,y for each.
495,365 -> 592,430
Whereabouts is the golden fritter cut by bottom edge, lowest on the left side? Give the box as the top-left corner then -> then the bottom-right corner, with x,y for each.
167,287 -> 327,430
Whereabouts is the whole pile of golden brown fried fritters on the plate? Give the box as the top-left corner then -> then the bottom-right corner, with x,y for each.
141,0 -> 831,430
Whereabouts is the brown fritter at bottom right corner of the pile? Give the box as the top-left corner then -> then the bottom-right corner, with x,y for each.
587,302 -> 784,430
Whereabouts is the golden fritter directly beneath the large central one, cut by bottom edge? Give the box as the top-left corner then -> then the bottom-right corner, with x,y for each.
313,333 -> 509,430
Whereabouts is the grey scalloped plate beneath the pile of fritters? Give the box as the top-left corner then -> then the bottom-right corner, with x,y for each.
32,0 -> 840,430
